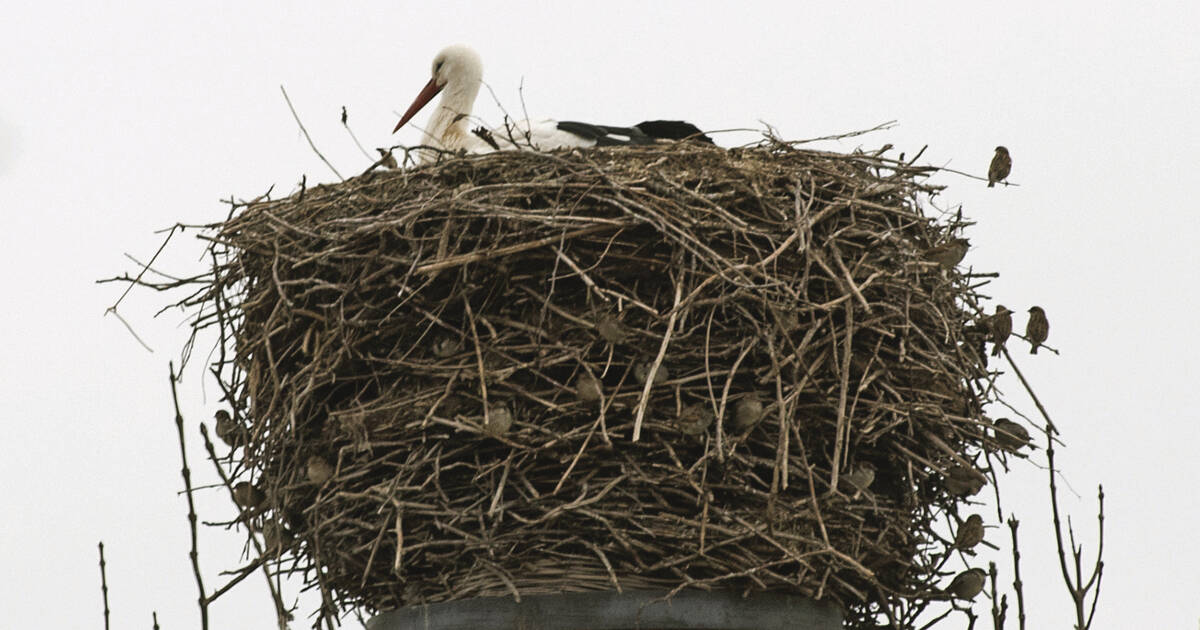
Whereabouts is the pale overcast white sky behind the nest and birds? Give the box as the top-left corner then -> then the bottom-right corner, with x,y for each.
0,1 -> 1200,630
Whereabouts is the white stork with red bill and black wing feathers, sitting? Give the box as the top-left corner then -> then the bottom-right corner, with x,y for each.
392,44 -> 713,160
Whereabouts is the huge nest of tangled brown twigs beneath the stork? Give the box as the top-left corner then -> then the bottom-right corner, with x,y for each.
188,140 -> 1027,624
